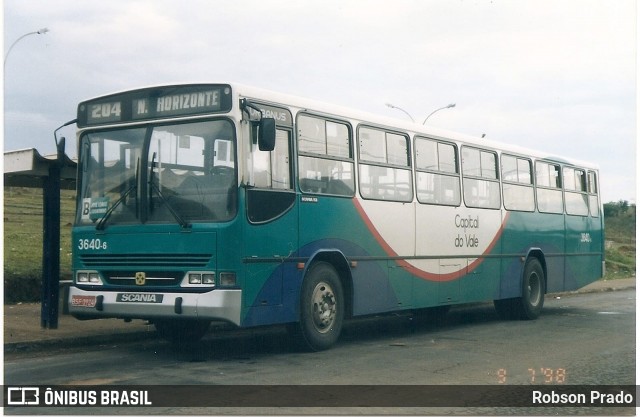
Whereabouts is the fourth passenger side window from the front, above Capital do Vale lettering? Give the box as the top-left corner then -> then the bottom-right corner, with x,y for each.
462,146 -> 500,209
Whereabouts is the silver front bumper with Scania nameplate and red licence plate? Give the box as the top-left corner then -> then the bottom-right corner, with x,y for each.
67,286 -> 242,326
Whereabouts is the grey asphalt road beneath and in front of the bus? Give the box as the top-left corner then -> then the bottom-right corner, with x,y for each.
5,290 -> 635,414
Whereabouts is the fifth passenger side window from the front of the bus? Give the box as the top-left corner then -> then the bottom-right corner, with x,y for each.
502,154 -> 535,211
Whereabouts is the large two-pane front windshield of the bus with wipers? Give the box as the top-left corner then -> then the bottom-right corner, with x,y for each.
76,120 -> 237,229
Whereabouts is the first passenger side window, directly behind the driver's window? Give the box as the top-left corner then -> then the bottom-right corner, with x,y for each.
297,114 -> 355,196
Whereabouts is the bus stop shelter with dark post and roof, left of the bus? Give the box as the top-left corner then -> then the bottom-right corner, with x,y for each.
4,146 -> 77,329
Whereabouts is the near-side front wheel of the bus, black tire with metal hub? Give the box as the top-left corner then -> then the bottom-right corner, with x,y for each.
293,262 -> 344,351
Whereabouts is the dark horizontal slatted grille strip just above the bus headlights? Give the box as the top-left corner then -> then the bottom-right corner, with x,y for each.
80,253 -> 211,269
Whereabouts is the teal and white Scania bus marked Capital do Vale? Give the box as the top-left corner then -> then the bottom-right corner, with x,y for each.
67,83 -> 604,351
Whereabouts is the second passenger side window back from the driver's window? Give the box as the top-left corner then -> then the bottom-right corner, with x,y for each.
358,127 -> 413,202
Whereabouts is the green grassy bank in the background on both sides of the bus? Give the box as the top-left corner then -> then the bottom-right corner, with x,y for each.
4,187 -> 636,303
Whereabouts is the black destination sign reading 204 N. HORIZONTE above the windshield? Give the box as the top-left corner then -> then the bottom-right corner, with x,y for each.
78,85 -> 232,126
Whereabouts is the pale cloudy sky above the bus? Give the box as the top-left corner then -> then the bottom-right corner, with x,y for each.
3,0 -> 637,202
